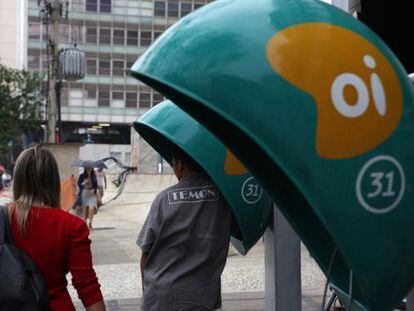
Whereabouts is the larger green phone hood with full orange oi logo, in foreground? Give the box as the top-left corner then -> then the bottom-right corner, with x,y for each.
131,0 -> 414,311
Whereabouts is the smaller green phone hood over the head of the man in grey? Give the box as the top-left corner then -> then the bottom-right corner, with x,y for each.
134,101 -> 272,255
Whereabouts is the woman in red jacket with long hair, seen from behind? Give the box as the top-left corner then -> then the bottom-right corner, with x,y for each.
10,146 -> 105,311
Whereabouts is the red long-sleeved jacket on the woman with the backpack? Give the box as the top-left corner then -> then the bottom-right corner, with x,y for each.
12,206 -> 103,311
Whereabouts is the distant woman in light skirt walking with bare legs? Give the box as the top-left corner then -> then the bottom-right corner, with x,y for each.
78,167 -> 98,229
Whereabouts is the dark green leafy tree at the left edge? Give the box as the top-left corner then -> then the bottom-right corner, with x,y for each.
0,64 -> 44,167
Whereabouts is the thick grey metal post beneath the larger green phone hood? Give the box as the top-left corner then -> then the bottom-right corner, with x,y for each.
264,204 -> 302,311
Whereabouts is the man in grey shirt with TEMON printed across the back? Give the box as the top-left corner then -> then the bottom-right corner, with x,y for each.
137,149 -> 231,311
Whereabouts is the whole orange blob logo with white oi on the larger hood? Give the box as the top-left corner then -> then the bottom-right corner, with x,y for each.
266,23 -> 403,159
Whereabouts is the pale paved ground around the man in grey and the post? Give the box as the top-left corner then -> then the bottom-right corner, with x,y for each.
67,176 -> 330,311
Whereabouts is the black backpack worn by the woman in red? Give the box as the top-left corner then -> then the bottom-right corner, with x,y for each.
0,206 -> 50,311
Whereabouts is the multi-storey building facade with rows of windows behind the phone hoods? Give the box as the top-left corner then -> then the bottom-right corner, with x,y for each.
25,0 -> 212,166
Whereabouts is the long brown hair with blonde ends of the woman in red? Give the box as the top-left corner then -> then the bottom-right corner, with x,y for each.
11,145 -> 60,233
